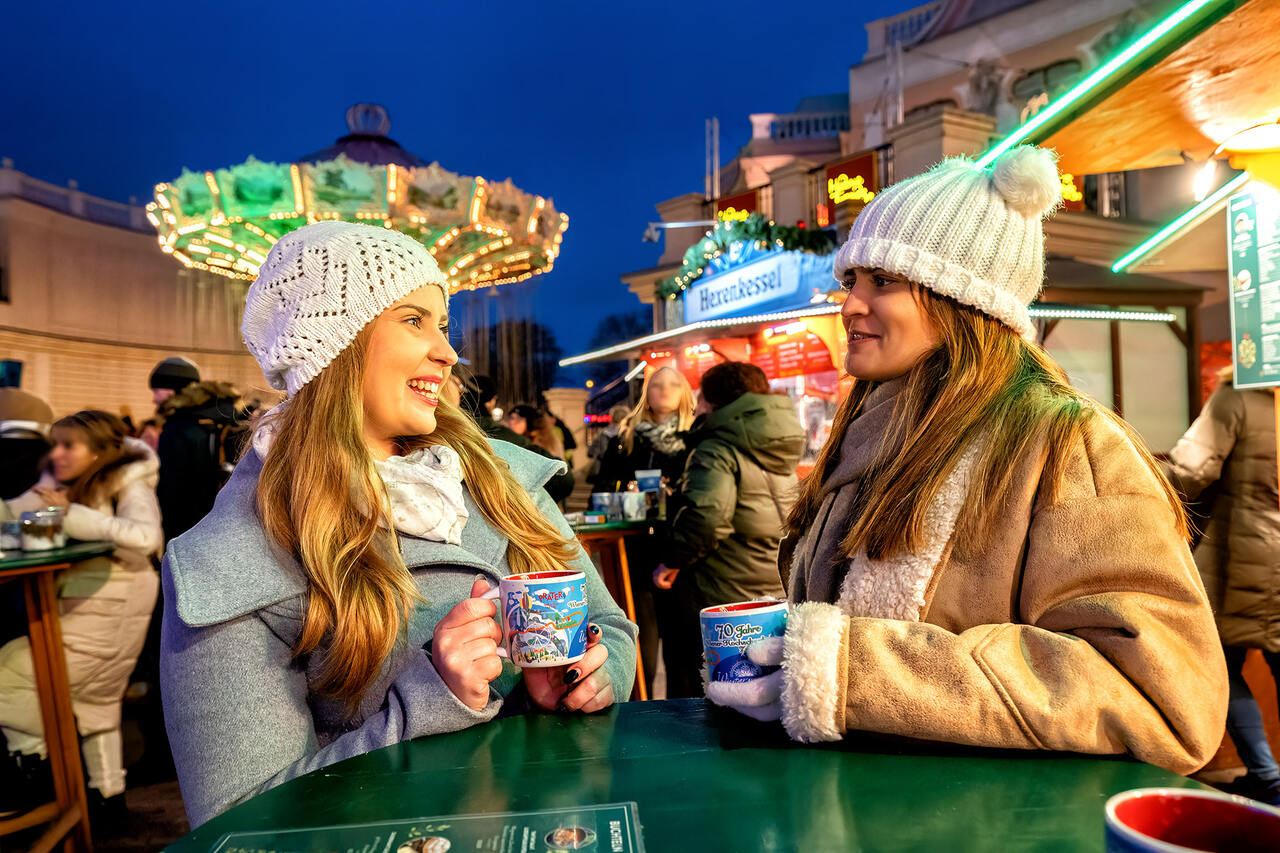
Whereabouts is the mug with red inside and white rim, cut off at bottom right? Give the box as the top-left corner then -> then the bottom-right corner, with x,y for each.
1106,788 -> 1280,853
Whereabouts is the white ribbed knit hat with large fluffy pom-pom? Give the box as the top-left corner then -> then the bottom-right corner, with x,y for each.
835,145 -> 1062,341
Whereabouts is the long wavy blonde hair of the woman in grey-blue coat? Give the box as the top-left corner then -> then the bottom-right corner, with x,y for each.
256,327 -> 573,712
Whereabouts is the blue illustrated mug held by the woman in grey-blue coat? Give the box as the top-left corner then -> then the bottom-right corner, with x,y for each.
484,571 -> 588,669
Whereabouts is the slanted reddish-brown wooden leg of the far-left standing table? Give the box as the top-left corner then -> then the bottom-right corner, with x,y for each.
23,571 -> 93,853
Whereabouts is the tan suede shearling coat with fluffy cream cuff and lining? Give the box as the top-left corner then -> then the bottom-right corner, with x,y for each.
781,381 -> 1228,774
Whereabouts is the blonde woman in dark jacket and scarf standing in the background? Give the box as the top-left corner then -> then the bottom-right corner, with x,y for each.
591,368 -> 694,693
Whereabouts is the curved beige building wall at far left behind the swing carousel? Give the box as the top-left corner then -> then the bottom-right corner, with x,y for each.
0,160 -> 275,423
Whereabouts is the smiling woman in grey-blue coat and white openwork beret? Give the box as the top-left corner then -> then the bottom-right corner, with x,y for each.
161,222 -> 636,825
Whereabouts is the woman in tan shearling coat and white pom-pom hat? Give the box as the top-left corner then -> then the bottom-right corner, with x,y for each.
708,146 -> 1228,774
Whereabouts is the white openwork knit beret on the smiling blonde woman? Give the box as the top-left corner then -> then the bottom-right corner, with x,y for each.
241,220 -> 449,397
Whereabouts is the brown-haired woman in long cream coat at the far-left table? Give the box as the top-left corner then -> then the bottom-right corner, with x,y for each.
0,410 -> 164,822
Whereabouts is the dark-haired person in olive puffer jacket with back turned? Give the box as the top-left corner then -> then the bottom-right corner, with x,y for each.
653,361 -> 805,698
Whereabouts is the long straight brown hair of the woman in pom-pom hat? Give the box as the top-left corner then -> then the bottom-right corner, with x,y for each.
787,287 -> 1187,560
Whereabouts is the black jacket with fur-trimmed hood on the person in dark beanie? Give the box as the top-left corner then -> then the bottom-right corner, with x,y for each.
156,380 -> 248,542
